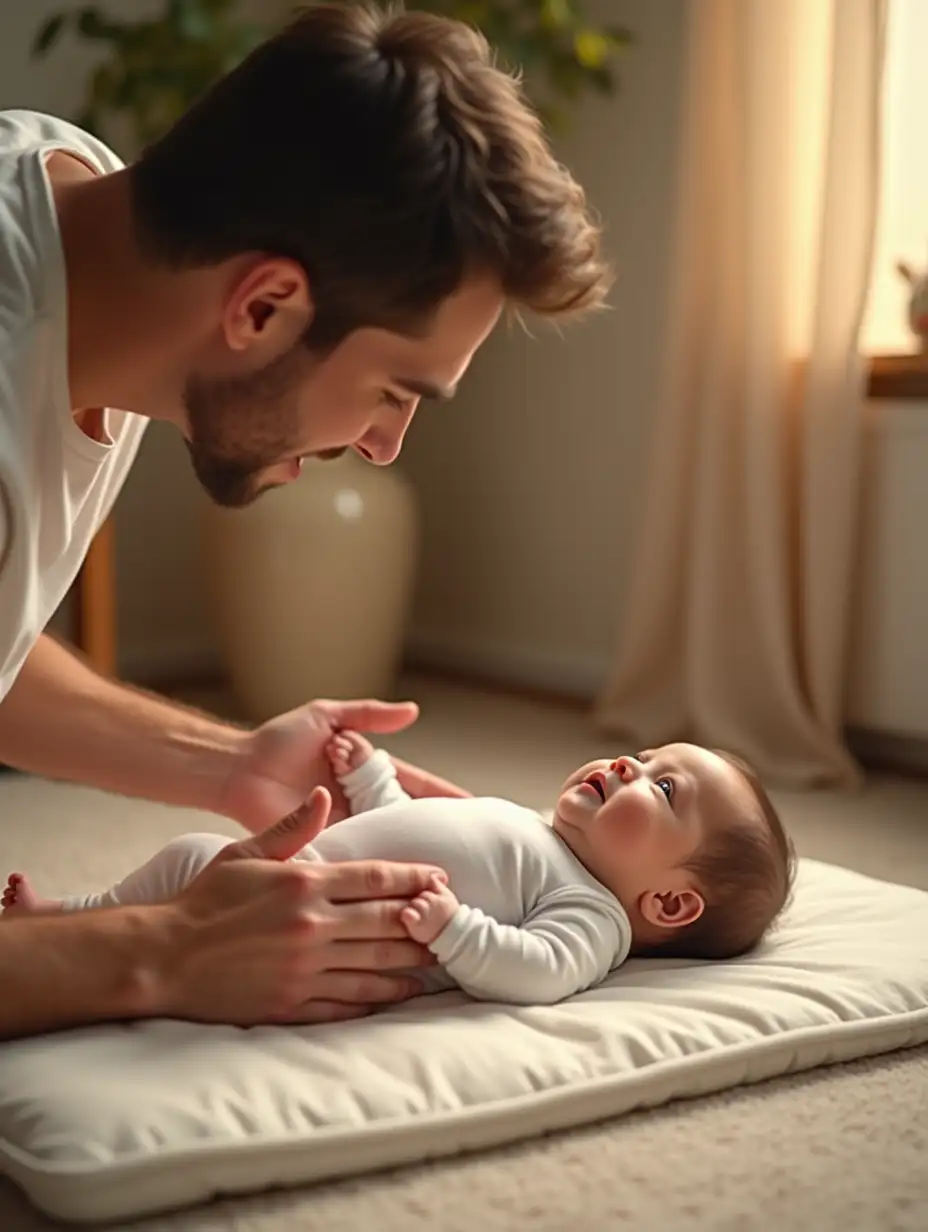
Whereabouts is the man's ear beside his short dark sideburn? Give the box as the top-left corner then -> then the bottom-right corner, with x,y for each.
222,257 -> 312,357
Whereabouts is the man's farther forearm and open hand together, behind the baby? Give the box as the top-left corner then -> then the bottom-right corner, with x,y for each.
0,637 -> 467,833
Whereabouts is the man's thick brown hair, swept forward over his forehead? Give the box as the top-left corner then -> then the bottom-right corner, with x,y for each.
129,2 -> 610,350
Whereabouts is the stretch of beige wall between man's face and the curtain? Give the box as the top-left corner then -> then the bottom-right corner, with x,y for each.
405,0 -> 684,694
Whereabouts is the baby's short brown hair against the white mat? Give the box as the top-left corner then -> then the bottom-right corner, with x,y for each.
649,749 -> 796,958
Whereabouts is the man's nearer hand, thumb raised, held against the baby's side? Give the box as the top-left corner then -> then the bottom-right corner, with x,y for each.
161,790 -> 445,1026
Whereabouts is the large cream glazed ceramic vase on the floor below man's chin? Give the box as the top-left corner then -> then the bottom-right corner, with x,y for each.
206,452 -> 418,722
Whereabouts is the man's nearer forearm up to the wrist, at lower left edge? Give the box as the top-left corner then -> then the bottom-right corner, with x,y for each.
0,907 -> 171,1040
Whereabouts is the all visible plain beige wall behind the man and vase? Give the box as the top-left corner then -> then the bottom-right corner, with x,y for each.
0,0 -> 683,691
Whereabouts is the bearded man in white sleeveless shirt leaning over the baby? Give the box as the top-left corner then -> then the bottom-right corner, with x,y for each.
0,4 -> 608,1037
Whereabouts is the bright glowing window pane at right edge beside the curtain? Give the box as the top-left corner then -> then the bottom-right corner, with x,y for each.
861,0 -> 928,355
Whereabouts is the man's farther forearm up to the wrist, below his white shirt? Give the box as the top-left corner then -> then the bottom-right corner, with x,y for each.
0,637 -> 246,811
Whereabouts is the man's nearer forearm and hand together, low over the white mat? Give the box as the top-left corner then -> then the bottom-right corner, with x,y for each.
0,791 -> 448,1040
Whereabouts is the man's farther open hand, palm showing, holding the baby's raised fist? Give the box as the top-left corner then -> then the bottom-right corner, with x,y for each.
217,700 -> 468,834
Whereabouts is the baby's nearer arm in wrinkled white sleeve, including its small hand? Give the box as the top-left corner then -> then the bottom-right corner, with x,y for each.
401,882 -> 625,1005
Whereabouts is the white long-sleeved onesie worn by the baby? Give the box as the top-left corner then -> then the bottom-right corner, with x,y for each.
65,750 -> 631,1005
